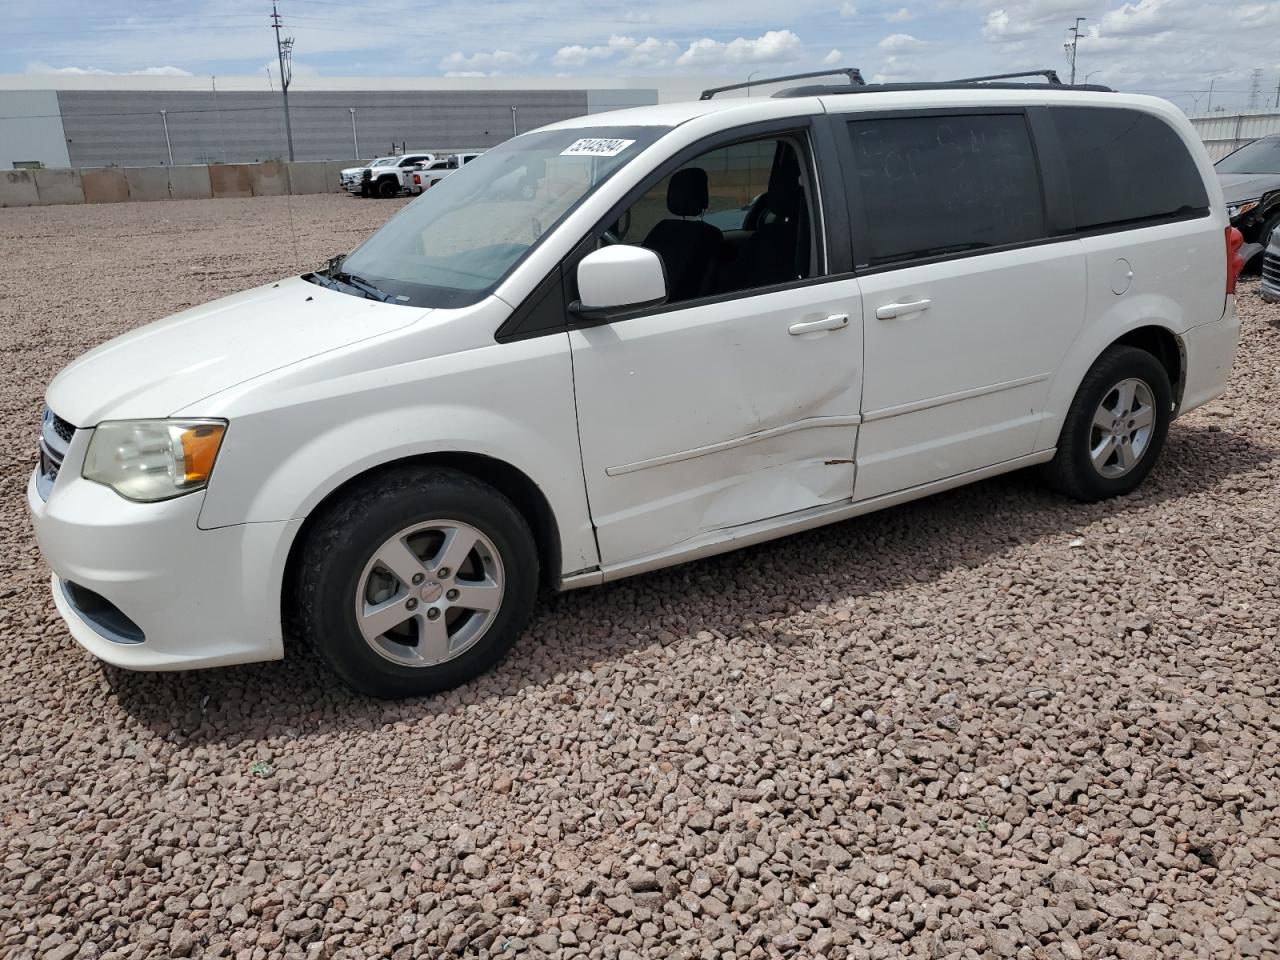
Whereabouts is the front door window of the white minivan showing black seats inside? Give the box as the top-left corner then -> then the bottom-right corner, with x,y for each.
604,137 -> 819,303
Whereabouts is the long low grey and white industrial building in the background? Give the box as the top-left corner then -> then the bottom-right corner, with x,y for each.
0,76 -> 658,170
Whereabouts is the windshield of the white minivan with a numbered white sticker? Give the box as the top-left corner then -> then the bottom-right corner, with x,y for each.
342,127 -> 667,307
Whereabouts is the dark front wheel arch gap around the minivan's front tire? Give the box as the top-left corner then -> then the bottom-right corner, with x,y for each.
280,452 -> 562,635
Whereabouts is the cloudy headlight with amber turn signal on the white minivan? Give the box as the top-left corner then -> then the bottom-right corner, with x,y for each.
81,420 -> 227,503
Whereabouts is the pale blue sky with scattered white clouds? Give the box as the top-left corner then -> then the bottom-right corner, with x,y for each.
0,0 -> 1280,113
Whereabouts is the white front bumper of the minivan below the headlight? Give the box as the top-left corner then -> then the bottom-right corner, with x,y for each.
27,442 -> 302,669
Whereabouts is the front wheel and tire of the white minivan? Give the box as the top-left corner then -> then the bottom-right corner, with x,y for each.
288,467 -> 539,699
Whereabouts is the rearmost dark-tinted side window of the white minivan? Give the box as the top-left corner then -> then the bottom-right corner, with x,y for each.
1050,106 -> 1208,229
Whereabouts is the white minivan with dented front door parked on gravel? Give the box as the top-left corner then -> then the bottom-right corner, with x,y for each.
28,73 -> 1240,696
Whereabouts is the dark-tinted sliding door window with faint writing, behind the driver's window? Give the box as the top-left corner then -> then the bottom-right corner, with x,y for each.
849,114 -> 1044,266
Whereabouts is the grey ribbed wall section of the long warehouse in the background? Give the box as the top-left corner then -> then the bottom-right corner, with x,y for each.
56,90 -> 614,166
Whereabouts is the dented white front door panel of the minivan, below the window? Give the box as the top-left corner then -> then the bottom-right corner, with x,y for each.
570,279 -> 863,563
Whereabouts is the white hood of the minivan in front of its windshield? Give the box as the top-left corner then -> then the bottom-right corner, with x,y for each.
46,276 -> 429,426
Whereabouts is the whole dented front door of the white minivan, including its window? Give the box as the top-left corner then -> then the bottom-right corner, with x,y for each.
570,129 -> 863,566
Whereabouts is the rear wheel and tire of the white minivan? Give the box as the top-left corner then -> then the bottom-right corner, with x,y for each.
1042,346 -> 1174,503
